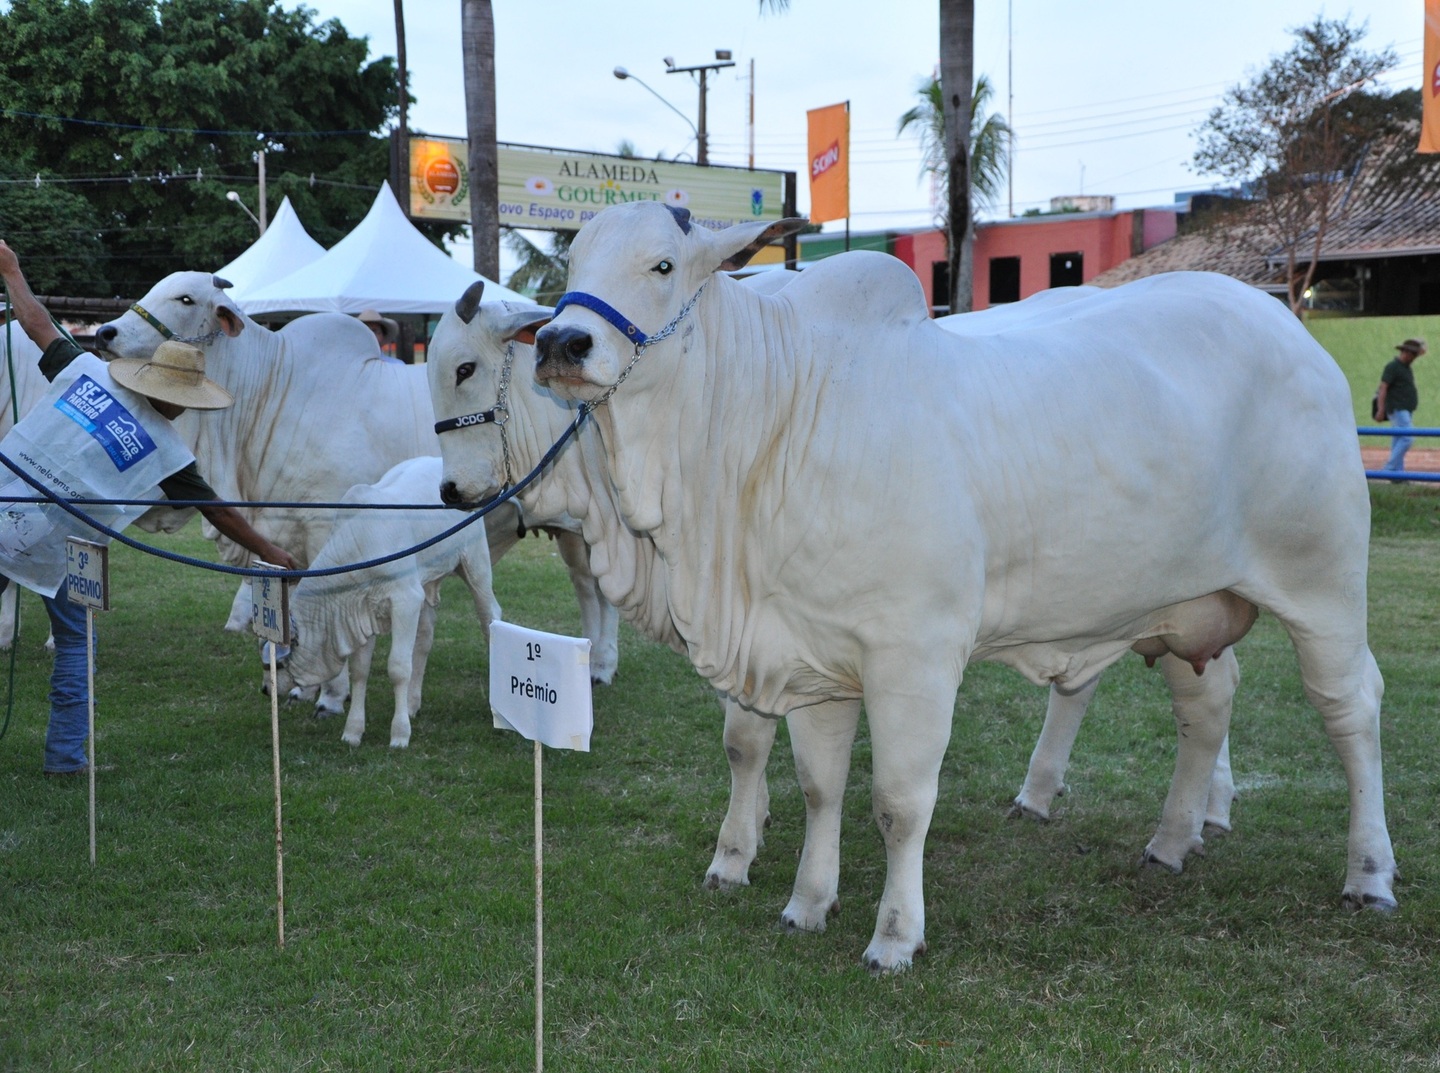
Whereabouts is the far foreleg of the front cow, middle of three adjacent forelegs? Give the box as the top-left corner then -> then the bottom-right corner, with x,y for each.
780,700 -> 860,932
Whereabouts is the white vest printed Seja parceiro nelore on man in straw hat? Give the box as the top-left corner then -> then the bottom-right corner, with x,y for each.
0,354 -> 194,596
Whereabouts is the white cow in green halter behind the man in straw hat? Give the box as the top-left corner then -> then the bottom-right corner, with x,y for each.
95,272 -> 618,713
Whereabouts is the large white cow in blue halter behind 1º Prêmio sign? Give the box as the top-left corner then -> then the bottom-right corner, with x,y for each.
512,203 -> 1395,969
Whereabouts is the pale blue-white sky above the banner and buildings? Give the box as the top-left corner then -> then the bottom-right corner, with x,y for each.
298,0 -> 1424,259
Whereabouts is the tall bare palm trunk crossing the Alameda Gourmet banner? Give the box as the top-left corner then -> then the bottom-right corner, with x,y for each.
459,0 -> 500,279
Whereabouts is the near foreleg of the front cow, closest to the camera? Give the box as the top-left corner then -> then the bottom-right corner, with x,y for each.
864,668 -> 959,972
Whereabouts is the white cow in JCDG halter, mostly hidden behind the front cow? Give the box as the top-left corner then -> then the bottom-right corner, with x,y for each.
428,282 -> 1238,904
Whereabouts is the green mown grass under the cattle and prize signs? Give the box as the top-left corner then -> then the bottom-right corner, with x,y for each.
0,486 -> 1440,1073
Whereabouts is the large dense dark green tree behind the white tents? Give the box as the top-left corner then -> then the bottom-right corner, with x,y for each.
0,0 -> 454,297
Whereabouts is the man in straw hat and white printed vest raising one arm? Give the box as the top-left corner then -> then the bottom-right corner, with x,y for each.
0,241 -> 298,776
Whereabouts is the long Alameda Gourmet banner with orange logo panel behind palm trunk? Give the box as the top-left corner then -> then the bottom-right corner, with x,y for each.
410,137 -> 785,230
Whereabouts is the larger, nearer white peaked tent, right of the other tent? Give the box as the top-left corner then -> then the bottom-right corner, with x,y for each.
239,183 -> 528,317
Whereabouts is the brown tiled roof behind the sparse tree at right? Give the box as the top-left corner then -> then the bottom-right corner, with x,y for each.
1089,121 -> 1440,291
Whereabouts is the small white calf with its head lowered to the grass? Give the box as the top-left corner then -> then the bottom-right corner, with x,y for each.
281,457 -> 501,749
